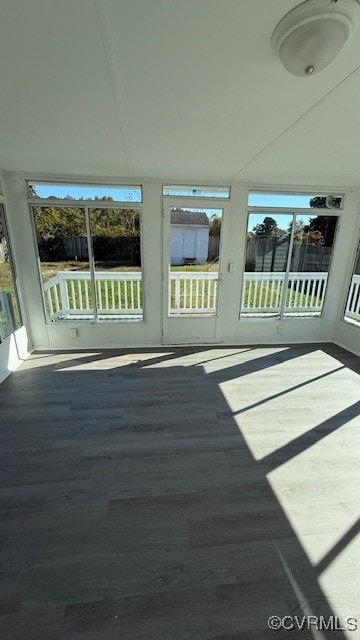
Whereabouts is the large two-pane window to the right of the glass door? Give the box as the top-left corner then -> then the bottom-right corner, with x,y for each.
241,201 -> 338,318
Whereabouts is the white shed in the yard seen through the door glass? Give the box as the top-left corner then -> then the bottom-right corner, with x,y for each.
170,209 -> 210,265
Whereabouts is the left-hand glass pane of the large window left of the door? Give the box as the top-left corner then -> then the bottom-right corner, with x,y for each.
33,207 -> 94,322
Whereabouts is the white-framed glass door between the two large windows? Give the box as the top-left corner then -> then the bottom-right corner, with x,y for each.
163,199 -> 228,344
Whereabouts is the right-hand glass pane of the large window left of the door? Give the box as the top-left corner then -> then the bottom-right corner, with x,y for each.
89,209 -> 143,322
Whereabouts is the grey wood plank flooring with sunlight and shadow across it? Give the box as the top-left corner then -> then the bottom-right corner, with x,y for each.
0,345 -> 360,640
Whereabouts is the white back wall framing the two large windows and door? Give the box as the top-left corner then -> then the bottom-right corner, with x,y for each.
4,174 -> 360,350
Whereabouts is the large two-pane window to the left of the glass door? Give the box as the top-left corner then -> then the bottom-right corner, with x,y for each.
32,197 -> 143,323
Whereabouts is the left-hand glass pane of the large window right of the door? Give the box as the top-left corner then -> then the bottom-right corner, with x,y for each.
241,213 -> 293,318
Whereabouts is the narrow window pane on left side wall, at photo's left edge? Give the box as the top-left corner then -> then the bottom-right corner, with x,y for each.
0,205 -> 22,340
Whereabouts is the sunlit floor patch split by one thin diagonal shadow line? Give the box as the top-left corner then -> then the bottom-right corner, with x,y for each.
219,356 -> 358,460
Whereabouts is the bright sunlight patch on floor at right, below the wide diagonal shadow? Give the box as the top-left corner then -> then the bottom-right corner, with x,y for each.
267,429 -> 360,564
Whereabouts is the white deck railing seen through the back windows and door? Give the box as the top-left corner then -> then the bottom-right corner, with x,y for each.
44,271 -> 332,321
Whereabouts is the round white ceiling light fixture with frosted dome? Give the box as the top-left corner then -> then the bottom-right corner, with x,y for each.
271,0 -> 360,76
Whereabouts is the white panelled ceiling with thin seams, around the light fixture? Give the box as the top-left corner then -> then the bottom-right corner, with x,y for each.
0,0 -> 360,187
